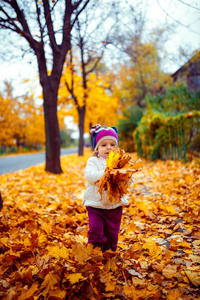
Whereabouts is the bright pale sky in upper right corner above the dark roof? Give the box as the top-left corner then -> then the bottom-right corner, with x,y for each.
147,0 -> 200,66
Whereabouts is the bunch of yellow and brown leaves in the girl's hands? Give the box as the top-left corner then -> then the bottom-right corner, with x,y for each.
97,147 -> 143,203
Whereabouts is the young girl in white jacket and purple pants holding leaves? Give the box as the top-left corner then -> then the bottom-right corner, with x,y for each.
83,124 -> 129,252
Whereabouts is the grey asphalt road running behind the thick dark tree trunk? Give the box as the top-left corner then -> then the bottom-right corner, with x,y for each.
0,148 -> 78,175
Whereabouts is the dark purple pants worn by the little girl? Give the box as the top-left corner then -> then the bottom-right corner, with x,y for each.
86,206 -> 122,252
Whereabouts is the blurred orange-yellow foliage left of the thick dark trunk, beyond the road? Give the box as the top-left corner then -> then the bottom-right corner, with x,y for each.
0,83 -> 45,151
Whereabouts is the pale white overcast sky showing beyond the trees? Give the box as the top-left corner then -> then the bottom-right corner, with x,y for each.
0,0 -> 200,137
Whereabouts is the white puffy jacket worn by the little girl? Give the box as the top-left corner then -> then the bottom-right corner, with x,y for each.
83,156 -> 129,209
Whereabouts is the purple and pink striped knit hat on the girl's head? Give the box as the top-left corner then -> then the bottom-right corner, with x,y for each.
90,124 -> 118,150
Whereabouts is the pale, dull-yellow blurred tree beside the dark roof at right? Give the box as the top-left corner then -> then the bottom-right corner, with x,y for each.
116,40 -> 172,108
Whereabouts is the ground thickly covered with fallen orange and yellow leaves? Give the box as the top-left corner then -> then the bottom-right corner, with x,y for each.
0,151 -> 200,300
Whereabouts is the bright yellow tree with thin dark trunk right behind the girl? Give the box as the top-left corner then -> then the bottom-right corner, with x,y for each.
59,54 -> 119,155
